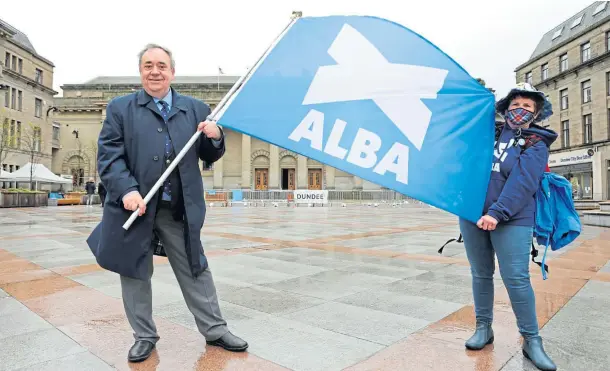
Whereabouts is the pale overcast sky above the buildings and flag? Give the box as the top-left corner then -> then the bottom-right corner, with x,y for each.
0,0 -> 592,95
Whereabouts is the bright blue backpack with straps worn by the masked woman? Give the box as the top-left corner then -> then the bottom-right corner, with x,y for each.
438,131 -> 582,280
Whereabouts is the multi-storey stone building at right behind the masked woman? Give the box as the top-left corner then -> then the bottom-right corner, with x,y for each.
516,1 -> 610,200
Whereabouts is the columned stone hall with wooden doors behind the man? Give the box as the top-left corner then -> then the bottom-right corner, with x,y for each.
52,75 -> 370,190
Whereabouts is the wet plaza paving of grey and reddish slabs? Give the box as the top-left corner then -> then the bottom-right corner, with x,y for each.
0,205 -> 610,371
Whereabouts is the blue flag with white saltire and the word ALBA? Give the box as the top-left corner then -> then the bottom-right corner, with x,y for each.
216,16 -> 495,222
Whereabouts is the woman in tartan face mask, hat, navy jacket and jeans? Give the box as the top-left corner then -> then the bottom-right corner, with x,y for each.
460,83 -> 557,370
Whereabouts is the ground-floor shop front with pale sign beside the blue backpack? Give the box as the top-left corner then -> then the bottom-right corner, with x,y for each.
549,148 -> 594,200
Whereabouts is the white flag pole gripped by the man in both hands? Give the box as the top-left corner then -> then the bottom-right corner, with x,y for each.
123,12 -> 302,230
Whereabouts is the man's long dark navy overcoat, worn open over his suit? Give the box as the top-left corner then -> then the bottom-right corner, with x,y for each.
87,90 -> 225,279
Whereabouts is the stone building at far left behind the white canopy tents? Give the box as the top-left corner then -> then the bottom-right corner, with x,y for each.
0,20 -> 58,179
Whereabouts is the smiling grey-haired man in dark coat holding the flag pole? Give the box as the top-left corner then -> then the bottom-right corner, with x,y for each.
87,44 -> 248,362
